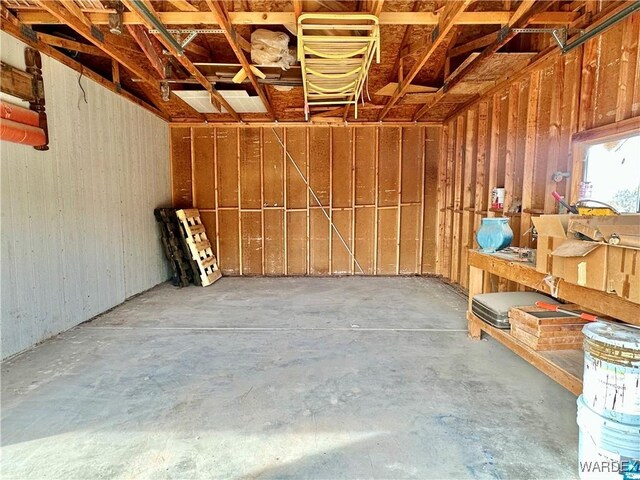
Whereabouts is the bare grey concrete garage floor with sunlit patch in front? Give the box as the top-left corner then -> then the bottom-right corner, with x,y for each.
1,277 -> 577,480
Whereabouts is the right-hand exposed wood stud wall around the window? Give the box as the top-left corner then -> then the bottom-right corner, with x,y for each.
436,15 -> 640,289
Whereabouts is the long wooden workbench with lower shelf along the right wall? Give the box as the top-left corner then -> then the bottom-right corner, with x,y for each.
467,250 -> 640,395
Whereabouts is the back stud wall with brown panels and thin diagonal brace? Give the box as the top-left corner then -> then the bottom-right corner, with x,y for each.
171,125 -> 441,276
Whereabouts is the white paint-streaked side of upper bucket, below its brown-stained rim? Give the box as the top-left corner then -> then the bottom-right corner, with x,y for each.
582,352 -> 640,418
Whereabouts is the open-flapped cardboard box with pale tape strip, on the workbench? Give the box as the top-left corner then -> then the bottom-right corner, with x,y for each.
551,240 -> 609,292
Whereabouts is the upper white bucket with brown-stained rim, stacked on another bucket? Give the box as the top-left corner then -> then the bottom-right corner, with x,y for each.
582,322 -> 640,425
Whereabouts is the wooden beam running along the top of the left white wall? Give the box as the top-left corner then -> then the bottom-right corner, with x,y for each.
0,4 -> 171,121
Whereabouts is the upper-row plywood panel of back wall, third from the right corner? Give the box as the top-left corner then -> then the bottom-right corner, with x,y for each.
378,127 -> 401,207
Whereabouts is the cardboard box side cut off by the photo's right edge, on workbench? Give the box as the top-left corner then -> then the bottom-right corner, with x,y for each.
607,246 -> 640,303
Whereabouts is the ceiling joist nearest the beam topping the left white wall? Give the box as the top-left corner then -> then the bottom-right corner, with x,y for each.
34,0 -> 203,118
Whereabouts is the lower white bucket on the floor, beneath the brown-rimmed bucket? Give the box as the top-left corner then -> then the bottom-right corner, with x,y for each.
578,395 -> 640,480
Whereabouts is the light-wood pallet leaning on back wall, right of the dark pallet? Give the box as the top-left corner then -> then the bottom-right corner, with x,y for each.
176,208 -> 222,287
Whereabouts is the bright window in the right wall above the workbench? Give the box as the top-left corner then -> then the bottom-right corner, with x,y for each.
578,135 -> 640,213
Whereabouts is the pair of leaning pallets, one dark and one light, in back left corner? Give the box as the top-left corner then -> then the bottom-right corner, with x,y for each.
153,208 -> 222,287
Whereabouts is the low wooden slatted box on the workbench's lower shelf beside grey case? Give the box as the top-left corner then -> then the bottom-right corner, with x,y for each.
509,305 -> 587,351
